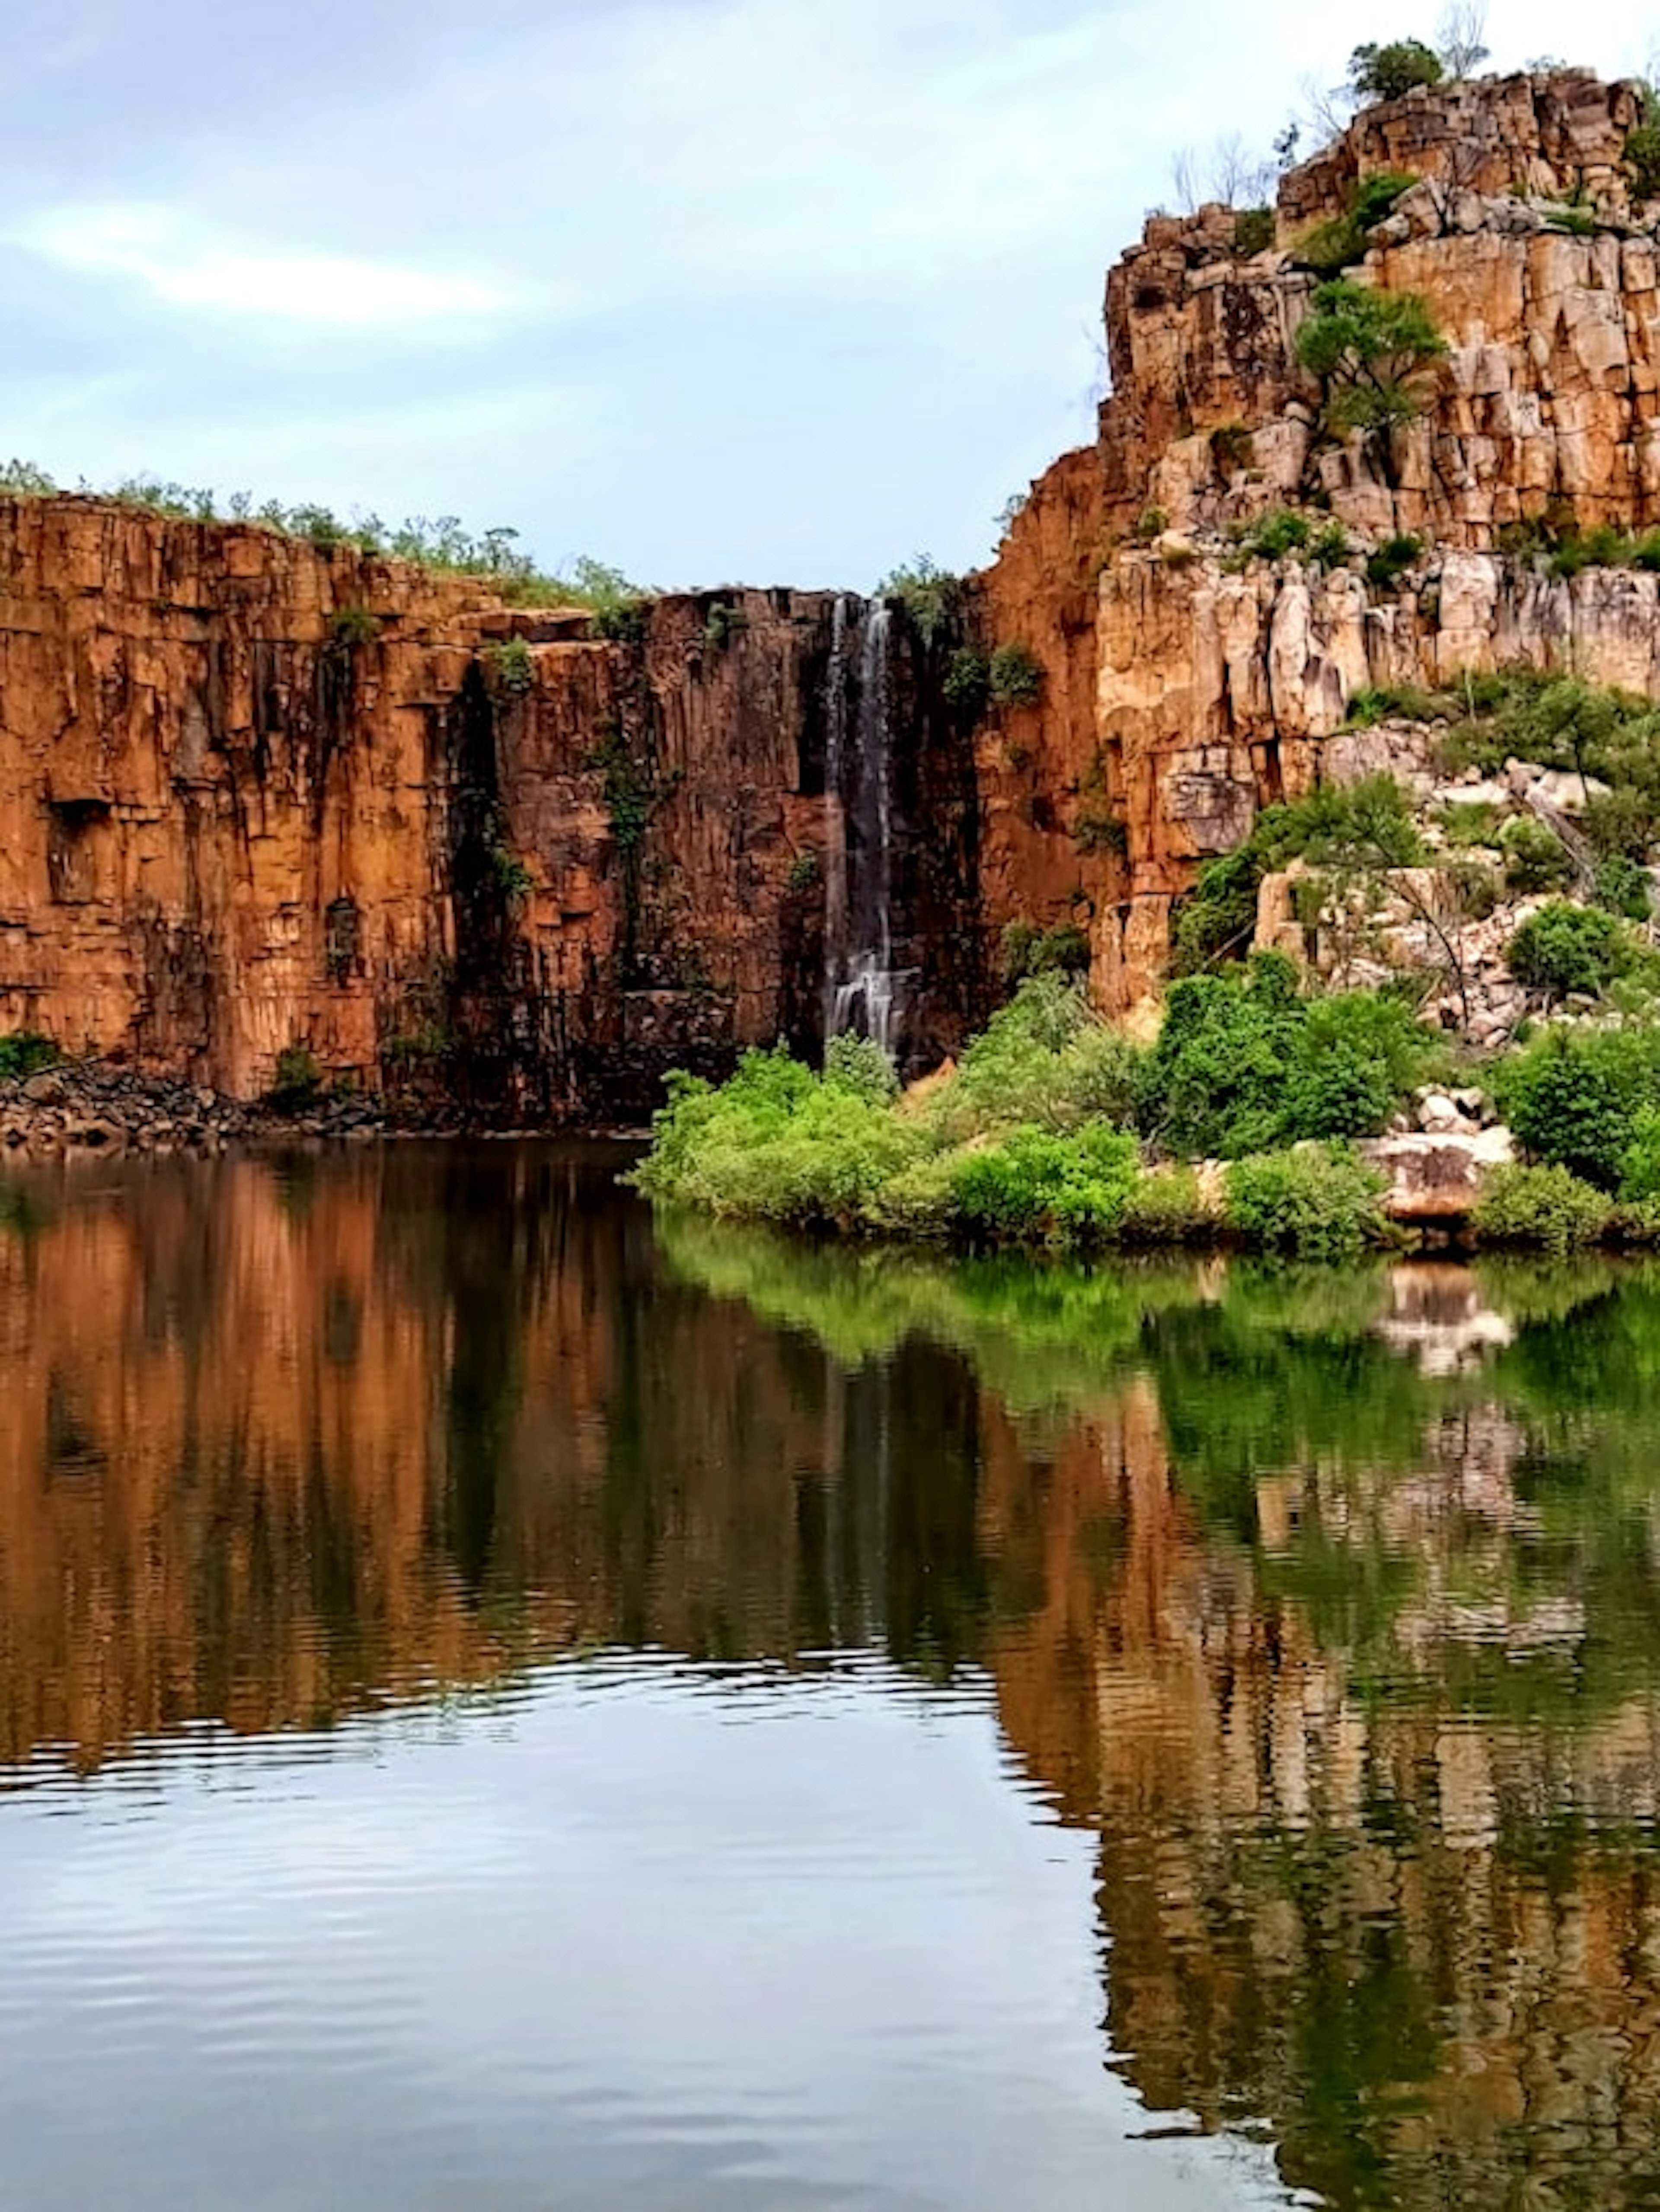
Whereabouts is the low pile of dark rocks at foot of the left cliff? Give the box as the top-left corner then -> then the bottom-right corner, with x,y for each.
0,1060 -> 409,1159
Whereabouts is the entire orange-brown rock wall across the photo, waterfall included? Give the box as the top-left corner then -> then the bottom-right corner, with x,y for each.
0,71 -> 1660,1122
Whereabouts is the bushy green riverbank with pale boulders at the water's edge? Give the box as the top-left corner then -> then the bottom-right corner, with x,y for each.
635,973 -> 1660,1259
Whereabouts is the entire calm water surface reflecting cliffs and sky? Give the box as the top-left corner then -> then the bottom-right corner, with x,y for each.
0,1146 -> 1660,2212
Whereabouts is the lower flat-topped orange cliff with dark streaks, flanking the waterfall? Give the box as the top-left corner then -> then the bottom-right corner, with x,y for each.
0,511 -> 978,1119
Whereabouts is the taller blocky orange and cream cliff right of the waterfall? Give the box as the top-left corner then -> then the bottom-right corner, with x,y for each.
983,71 -> 1660,1009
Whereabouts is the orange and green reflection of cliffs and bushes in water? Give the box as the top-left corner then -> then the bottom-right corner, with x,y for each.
0,1146 -> 1660,2206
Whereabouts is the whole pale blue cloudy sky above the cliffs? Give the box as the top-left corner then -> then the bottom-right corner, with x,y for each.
0,0 -> 1658,588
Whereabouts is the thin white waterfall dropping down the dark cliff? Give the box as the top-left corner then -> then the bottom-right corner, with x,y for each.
824,599 -> 905,1053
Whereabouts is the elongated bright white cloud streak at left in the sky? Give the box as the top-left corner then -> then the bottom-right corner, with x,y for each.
9,204 -> 524,338
